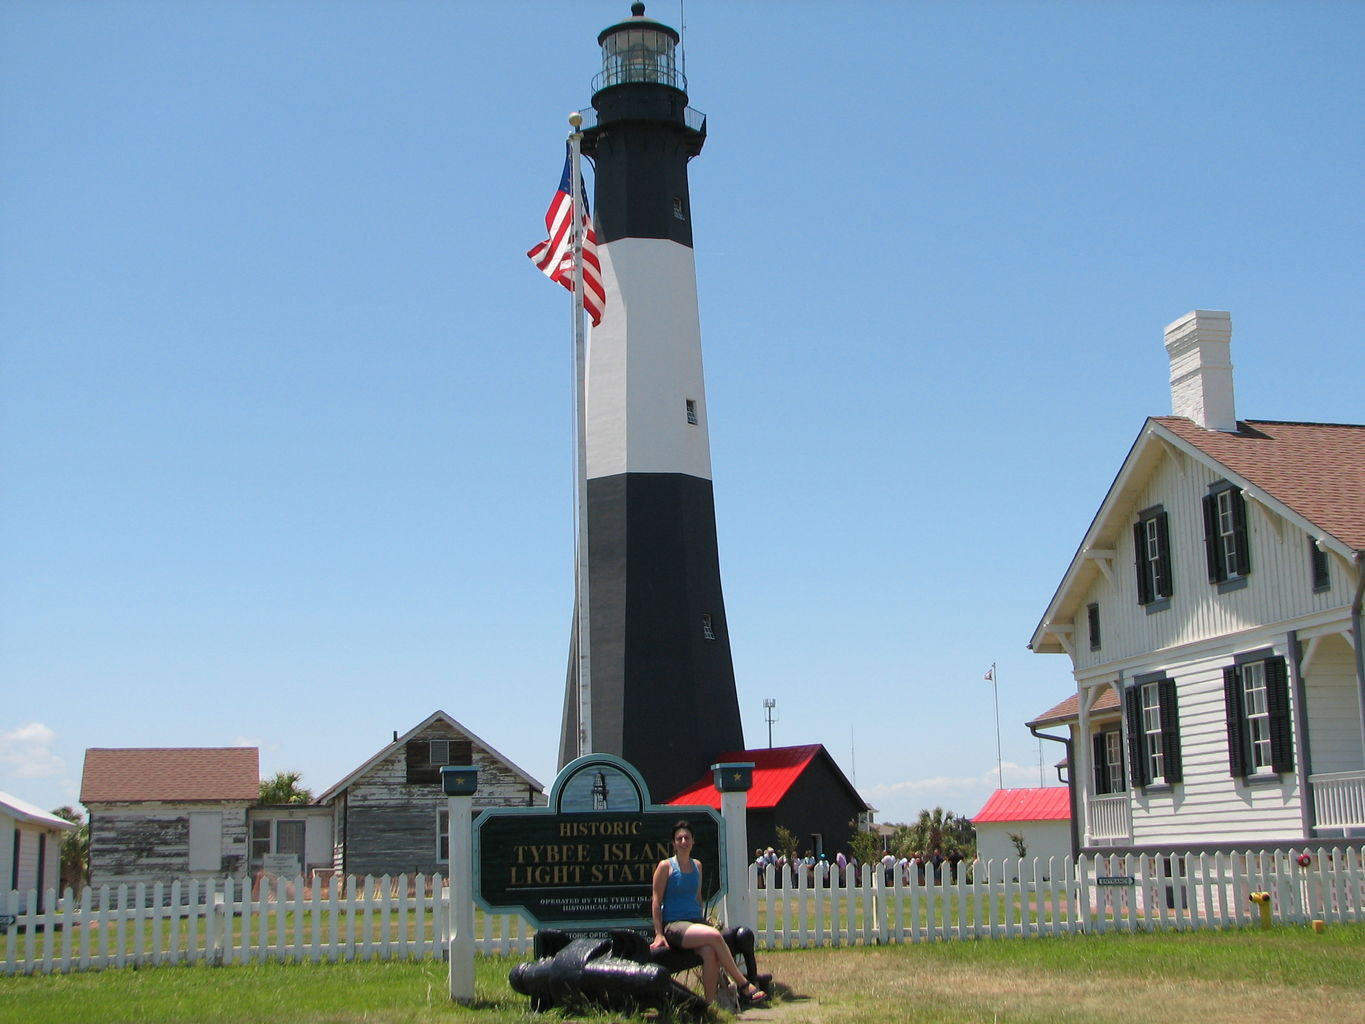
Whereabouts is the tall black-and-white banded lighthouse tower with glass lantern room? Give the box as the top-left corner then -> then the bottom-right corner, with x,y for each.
560,3 -> 744,800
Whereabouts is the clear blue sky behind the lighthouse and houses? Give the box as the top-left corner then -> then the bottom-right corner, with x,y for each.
0,0 -> 1365,821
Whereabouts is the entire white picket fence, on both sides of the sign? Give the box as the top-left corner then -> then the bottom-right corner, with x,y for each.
0,849 -> 1365,975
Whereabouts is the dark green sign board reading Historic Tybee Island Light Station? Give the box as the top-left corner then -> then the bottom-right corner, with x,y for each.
474,754 -> 726,928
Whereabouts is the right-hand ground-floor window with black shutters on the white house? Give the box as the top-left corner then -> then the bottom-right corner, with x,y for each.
1223,651 -> 1294,778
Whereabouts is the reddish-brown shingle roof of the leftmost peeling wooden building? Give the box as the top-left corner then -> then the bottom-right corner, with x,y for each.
81,747 -> 261,804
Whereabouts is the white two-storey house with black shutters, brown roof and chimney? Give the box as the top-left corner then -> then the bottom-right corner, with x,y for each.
1029,310 -> 1365,852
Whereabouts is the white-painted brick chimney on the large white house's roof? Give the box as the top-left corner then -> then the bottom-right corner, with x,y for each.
1166,310 -> 1237,433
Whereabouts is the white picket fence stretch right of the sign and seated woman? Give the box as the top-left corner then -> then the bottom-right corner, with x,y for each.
751,849 -> 1365,949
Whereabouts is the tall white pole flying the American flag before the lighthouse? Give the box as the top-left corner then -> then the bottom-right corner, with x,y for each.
569,120 -> 592,756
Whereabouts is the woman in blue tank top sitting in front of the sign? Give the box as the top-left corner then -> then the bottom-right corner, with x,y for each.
650,822 -> 767,1005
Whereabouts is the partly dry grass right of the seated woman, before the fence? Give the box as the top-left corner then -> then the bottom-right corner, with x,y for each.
764,930 -> 1365,1024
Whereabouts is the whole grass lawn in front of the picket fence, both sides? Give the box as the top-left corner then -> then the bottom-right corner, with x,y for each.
0,924 -> 1365,1024
